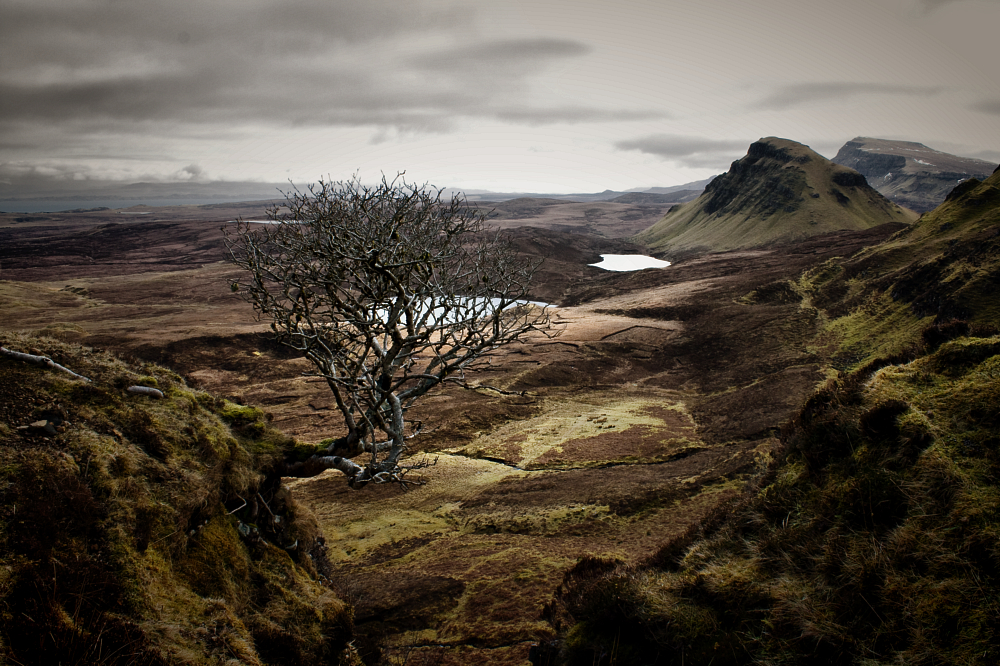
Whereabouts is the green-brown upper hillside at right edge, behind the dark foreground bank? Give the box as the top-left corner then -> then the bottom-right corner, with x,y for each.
808,163 -> 1000,368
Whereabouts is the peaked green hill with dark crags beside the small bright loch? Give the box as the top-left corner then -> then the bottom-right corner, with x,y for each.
635,137 -> 912,258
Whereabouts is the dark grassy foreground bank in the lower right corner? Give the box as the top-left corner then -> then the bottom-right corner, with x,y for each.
551,336 -> 1000,666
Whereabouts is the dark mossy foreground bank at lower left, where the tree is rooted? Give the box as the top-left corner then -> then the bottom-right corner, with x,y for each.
0,335 -> 360,664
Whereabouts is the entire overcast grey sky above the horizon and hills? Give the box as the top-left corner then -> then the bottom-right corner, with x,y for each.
0,0 -> 1000,195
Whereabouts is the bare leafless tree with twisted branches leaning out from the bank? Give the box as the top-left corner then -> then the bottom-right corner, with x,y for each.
225,174 -> 549,487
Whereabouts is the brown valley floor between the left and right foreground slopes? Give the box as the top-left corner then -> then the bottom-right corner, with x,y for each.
0,205 -> 893,664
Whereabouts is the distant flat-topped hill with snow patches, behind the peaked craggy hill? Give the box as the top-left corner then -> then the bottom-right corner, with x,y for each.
833,136 -> 996,213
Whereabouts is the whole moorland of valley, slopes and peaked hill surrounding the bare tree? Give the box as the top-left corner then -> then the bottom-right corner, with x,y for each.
0,136 -> 1000,664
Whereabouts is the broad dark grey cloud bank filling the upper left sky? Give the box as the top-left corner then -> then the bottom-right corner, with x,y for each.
0,0 -> 608,148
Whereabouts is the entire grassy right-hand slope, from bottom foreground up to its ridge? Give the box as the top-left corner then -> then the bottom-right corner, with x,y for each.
542,172 -> 1000,666
